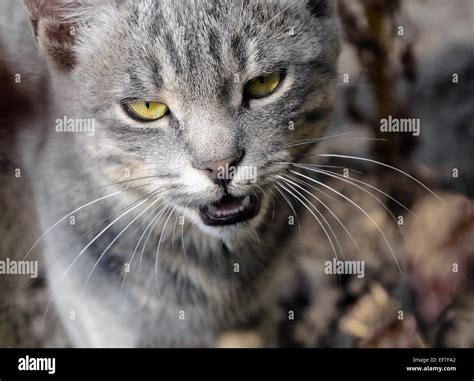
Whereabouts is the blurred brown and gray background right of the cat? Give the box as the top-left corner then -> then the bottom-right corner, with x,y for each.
260,0 -> 474,347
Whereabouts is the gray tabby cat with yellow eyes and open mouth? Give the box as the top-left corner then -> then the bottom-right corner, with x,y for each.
1,0 -> 339,347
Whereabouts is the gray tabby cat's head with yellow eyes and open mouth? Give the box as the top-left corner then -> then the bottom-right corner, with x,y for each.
25,0 -> 339,238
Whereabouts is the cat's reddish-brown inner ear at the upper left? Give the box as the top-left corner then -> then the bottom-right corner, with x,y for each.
23,0 -> 81,72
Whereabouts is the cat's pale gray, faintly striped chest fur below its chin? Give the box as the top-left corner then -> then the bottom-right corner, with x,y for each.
39,203 -> 288,347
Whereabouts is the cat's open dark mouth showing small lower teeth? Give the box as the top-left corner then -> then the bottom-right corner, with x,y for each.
199,195 -> 260,226
